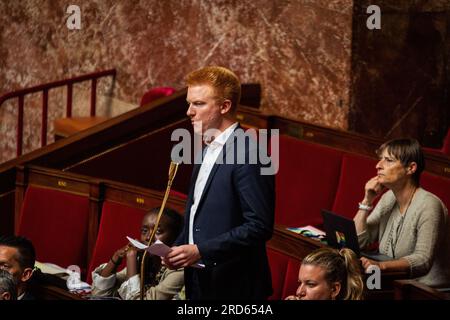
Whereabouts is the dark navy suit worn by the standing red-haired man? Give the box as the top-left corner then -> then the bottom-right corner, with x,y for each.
176,127 -> 275,299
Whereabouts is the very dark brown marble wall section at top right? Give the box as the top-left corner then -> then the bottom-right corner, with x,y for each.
349,0 -> 450,148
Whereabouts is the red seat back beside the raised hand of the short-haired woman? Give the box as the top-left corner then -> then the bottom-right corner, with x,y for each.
333,154 -> 377,218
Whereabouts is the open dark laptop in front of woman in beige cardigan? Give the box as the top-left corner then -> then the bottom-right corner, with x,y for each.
322,209 -> 393,261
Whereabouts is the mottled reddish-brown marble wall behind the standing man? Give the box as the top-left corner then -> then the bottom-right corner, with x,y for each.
0,0 -> 353,162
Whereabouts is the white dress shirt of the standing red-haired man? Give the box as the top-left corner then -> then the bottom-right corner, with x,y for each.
189,122 -> 238,244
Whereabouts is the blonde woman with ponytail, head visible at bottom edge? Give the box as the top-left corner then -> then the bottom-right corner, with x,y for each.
286,248 -> 364,300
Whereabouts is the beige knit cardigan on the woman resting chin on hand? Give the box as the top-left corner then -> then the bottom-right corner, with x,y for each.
358,188 -> 450,287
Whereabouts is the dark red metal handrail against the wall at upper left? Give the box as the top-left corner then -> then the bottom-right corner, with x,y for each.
0,69 -> 116,157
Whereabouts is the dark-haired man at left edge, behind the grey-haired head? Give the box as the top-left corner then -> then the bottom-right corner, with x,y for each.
0,236 -> 36,300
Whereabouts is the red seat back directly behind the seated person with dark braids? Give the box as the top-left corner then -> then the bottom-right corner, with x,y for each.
87,201 -> 146,283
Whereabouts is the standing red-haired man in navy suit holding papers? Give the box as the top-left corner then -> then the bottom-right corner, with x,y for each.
163,67 -> 275,300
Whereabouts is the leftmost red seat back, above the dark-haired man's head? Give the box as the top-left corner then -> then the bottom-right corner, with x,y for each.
18,186 -> 89,271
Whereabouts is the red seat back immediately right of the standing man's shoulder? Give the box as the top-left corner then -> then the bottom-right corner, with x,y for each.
275,135 -> 342,227
